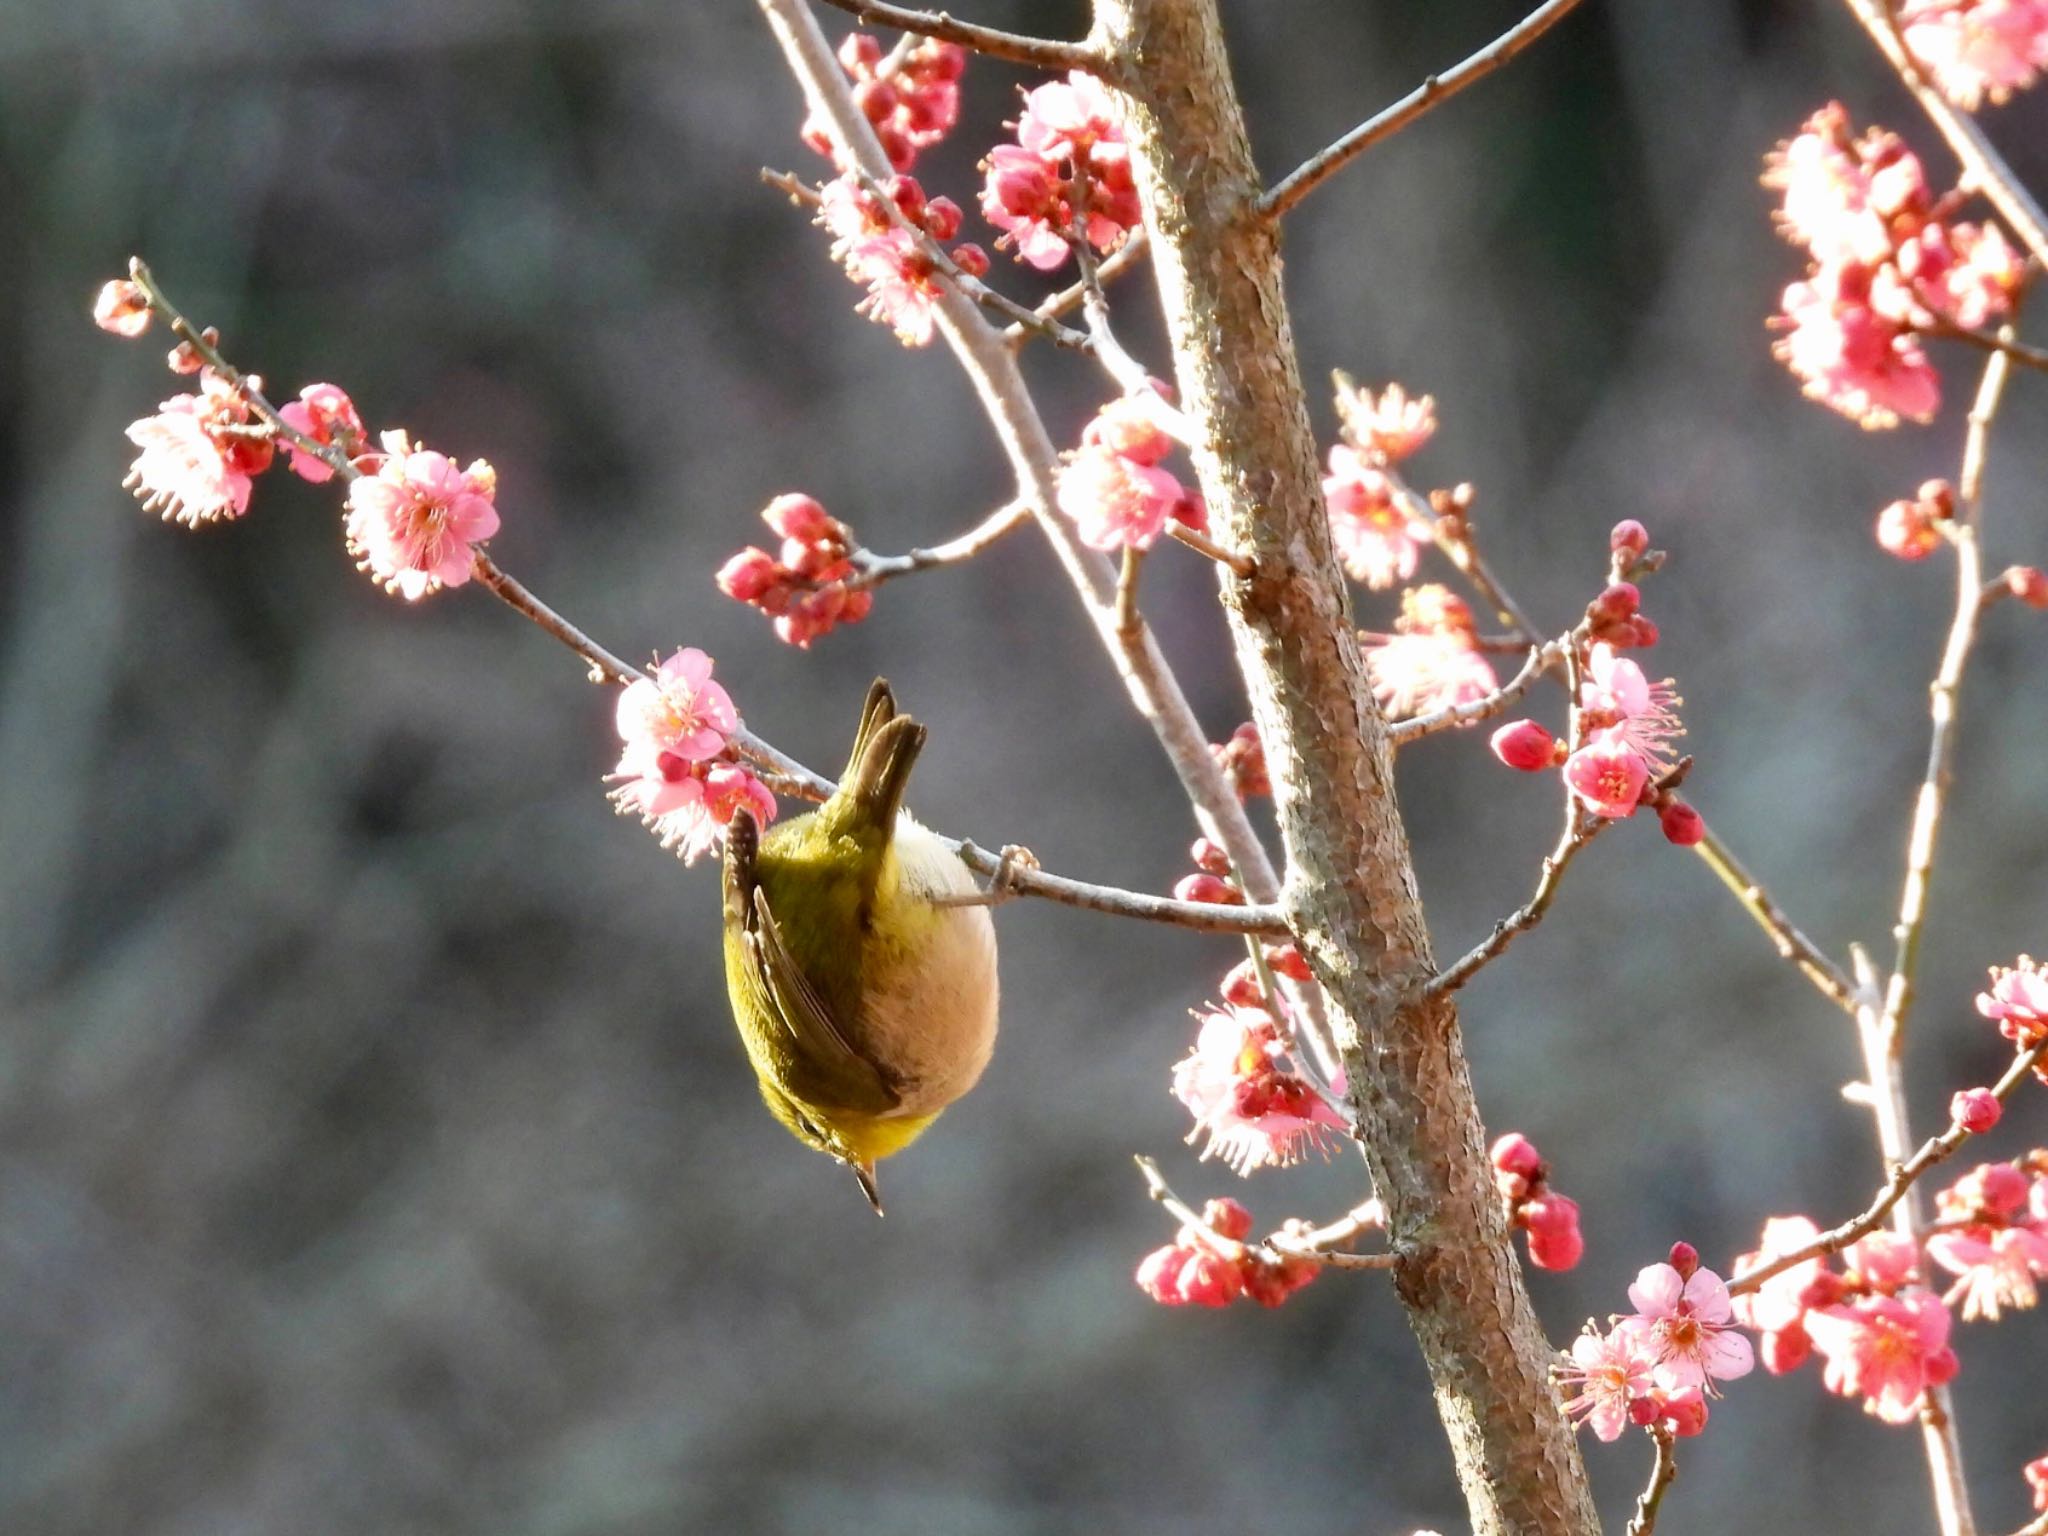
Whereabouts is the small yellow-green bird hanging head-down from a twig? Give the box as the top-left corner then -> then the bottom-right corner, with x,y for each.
725,680 -> 995,1214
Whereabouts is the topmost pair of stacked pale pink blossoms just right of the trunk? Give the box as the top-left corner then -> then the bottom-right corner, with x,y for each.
1323,383 -> 1436,592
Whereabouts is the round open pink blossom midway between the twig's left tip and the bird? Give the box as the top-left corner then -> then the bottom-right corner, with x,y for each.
344,432 -> 498,602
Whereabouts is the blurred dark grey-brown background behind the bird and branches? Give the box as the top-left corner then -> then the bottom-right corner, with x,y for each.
0,0 -> 2048,1536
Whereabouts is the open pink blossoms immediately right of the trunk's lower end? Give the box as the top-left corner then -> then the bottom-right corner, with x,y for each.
1556,1243 -> 1755,1440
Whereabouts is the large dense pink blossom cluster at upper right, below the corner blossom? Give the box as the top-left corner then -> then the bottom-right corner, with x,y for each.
1763,102 -> 2025,428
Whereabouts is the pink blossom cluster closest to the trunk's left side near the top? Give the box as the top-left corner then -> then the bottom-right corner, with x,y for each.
981,70 -> 1143,272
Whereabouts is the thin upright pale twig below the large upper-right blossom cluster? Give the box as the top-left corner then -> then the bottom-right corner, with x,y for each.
1882,352 -> 2011,1055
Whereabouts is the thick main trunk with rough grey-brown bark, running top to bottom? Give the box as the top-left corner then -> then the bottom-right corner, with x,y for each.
1094,0 -> 1597,1536
